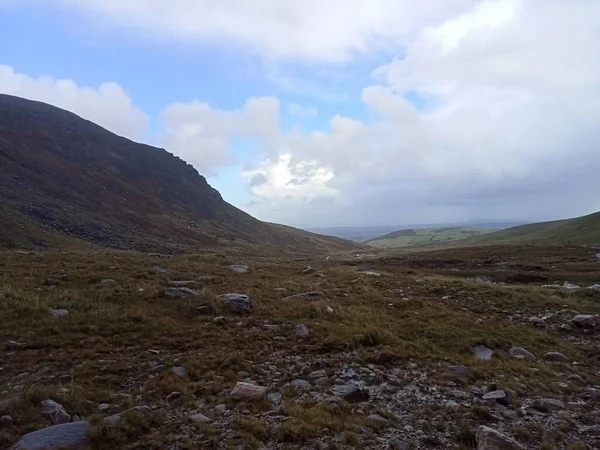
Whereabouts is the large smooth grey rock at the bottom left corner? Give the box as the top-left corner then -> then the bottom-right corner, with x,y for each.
11,421 -> 90,450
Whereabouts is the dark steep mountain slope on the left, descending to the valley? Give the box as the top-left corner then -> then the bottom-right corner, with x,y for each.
0,95 -> 357,252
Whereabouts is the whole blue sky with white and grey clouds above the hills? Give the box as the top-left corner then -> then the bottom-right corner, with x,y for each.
0,0 -> 600,227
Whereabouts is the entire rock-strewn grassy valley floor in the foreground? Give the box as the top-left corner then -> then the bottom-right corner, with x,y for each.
0,247 -> 600,450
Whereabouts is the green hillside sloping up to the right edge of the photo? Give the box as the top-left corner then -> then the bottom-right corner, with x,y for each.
457,212 -> 600,245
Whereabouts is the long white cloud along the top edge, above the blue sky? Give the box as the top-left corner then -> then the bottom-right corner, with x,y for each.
38,0 -> 476,62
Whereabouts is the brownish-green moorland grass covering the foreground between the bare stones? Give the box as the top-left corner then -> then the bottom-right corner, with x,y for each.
0,244 -> 600,449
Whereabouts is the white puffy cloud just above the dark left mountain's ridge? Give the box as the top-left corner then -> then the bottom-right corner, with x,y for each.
0,65 -> 148,139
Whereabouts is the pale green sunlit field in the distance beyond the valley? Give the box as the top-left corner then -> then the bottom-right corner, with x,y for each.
366,227 -> 496,248
